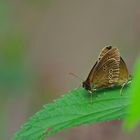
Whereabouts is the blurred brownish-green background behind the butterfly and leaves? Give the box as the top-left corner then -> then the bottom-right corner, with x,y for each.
0,0 -> 140,140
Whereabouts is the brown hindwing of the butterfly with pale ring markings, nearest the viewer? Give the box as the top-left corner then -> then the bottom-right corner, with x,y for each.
92,58 -> 119,89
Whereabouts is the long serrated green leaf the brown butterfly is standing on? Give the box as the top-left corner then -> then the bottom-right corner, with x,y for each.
14,87 -> 129,140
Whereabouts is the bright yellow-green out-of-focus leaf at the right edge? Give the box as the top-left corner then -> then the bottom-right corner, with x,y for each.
124,59 -> 140,131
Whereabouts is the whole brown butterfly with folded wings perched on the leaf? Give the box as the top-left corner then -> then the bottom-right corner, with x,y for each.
83,46 -> 130,93
